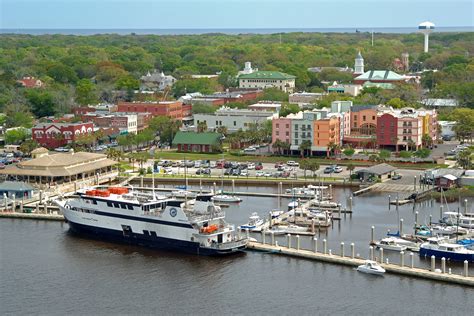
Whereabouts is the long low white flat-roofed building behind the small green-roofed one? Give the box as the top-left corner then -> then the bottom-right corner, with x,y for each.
194,106 -> 278,133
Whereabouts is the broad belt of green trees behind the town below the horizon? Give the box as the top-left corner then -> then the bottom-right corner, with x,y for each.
0,33 -> 474,121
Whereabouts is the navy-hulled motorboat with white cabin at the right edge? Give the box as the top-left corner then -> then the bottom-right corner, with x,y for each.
420,237 -> 474,262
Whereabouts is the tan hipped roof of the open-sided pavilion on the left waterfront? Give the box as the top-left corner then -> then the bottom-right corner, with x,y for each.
0,152 -> 117,177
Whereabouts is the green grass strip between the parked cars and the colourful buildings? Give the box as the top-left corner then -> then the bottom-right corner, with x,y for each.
151,151 -> 446,169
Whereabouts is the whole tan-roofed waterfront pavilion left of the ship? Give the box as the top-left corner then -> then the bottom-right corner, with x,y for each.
0,151 -> 118,185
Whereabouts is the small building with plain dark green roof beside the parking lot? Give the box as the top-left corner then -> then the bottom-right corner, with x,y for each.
173,131 -> 222,153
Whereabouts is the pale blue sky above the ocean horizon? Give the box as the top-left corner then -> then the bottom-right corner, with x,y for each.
0,0 -> 474,29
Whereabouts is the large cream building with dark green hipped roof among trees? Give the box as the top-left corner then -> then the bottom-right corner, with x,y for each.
238,71 -> 296,93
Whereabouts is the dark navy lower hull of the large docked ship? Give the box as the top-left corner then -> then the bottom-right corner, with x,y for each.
68,220 -> 245,256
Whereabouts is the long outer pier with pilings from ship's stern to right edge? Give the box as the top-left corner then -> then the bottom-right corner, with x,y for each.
248,241 -> 474,287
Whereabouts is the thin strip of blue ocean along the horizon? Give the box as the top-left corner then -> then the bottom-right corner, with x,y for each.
0,26 -> 474,35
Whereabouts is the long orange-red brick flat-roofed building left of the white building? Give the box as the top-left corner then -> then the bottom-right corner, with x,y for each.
117,101 -> 183,120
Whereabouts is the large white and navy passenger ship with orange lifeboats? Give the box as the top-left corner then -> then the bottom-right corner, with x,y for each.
56,187 -> 248,255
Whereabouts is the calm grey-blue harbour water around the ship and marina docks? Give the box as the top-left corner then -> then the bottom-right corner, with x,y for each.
0,187 -> 474,315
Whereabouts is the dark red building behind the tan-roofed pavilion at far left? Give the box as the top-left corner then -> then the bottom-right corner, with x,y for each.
31,123 -> 94,148
